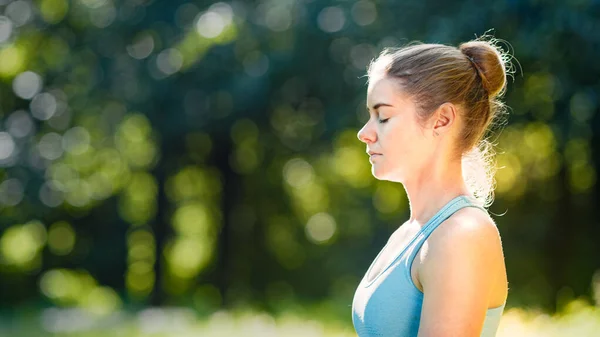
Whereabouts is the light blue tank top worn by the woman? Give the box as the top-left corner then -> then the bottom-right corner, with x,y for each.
352,195 -> 506,337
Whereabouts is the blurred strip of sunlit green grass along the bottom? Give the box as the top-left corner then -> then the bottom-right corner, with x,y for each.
0,300 -> 600,337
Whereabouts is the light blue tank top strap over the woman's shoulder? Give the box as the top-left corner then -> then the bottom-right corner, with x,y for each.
408,195 -> 487,264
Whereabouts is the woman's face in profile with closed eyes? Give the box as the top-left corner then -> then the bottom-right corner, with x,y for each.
358,76 -> 434,183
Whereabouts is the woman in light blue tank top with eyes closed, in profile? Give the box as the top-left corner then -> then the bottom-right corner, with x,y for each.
352,40 -> 508,337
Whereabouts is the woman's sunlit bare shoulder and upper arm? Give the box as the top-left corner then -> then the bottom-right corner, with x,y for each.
419,207 -> 506,336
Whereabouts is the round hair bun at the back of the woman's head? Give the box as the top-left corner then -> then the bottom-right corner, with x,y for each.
458,40 -> 506,98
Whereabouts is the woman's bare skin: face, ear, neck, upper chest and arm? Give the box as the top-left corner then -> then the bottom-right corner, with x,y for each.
358,75 -> 508,337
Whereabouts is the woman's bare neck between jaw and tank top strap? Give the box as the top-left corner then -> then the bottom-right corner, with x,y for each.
403,155 -> 470,226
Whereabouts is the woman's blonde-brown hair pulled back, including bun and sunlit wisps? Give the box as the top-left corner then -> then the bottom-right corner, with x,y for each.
368,36 -> 512,207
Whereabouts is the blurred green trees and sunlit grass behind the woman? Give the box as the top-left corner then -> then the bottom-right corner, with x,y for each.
0,0 -> 600,336
